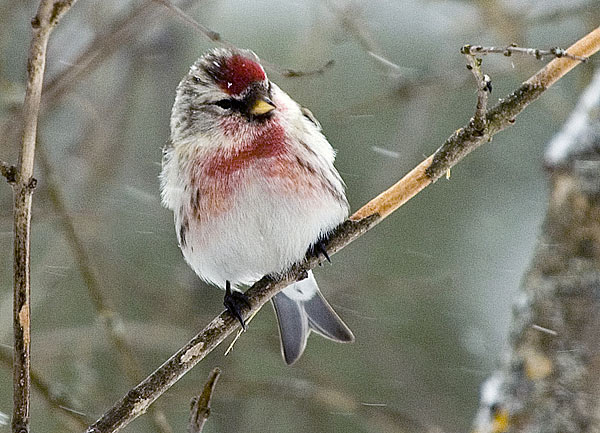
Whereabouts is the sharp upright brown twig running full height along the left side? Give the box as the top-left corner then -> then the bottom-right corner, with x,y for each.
12,0 -> 76,433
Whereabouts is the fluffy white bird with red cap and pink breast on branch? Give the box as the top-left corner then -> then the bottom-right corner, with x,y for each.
160,48 -> 354,365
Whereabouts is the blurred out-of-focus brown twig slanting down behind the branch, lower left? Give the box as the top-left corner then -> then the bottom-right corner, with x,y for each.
38,146 -> 173,433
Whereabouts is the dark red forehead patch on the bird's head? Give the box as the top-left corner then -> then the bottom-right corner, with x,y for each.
217,54 -> 266,95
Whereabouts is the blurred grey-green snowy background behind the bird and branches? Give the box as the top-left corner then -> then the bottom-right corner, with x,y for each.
0,0 -> 600,433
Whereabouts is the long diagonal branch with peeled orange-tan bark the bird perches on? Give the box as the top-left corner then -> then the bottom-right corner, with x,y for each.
87,28 -> 600,433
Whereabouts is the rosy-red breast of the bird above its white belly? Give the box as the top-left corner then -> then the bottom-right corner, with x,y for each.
187,124 -> 323,221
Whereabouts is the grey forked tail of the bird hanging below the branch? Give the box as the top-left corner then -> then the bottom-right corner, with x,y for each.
272,272 -> 354,364
